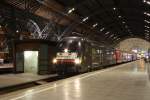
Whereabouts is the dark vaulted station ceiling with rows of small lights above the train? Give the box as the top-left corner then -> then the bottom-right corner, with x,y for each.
1,0 -> 150,41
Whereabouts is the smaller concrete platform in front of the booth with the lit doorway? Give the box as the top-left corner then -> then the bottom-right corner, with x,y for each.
0,73 -> 56,88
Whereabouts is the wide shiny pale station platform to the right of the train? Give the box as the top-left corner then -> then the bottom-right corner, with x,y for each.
0,60 -> 150,100
